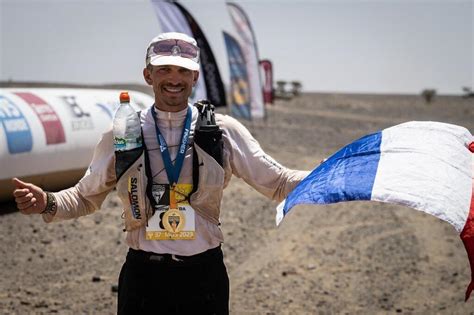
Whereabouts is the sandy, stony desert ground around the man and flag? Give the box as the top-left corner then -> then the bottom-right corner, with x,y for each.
0,94 -> 474,314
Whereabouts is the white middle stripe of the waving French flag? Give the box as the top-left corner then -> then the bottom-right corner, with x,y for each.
372,122 -> 472,232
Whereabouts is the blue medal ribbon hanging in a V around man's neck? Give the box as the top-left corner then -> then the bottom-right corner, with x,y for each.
151,105 -> 192,187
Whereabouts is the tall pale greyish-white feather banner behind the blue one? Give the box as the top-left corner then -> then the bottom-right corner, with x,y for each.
227,3 -> 265,118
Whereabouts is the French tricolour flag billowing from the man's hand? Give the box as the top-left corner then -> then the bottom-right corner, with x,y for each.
276,121 -> 474,301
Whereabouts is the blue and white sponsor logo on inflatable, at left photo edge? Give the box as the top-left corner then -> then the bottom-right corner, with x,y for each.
0,96 -> 33,154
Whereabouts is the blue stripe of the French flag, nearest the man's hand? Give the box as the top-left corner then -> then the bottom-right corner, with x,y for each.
283,132 -> 382,215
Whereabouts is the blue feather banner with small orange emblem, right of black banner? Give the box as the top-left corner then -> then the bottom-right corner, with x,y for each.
223,32 -> 251,120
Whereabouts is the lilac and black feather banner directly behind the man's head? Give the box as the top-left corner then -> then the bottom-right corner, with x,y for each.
152,0 -> 226,106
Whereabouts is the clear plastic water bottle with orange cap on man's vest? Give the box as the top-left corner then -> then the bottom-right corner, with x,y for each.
113,92 -> 143,151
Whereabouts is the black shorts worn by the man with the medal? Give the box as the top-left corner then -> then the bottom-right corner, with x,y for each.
117,246 -> 229,315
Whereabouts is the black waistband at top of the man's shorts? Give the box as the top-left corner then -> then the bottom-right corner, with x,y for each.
127,245 -> 223,265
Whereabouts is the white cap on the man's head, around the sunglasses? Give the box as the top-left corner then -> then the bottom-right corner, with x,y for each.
146,32 -> 199,71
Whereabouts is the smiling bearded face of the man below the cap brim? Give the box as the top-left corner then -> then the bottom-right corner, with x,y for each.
143,65 -> 199,112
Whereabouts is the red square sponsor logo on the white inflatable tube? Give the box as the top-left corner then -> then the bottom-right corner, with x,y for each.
13,92 -> 66,145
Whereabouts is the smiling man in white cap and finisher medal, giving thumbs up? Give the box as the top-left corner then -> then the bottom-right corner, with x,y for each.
13,33 -> 308,314
